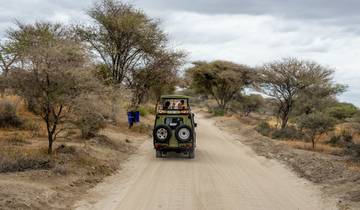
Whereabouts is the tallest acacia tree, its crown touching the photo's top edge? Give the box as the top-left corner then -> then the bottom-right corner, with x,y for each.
78,0 -> 167,83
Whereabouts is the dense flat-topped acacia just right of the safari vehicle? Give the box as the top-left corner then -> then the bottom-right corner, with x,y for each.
187,61 -> 253,110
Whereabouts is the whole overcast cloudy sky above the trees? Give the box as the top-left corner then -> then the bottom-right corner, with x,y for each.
0,0 -> 360,106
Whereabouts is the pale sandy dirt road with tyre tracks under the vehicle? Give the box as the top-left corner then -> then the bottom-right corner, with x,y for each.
75,116 -> 336,210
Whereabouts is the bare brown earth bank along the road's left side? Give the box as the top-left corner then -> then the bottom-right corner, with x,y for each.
0,125 -> 149,210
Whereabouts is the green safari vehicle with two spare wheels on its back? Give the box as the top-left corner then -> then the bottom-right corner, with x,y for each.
153,95 -> 197,158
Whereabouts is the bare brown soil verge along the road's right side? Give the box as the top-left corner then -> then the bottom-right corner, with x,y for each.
213,114 -> 360,210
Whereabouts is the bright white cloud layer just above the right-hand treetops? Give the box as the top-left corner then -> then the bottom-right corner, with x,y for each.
162,12 -> 360,106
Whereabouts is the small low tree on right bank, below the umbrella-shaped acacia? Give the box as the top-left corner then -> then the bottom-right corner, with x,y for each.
297,112 -> 336,149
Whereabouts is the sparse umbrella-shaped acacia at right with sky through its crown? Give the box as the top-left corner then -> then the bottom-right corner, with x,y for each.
259,58 -> 345,129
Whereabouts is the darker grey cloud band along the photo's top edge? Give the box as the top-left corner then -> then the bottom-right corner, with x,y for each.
133,0 -> 360,19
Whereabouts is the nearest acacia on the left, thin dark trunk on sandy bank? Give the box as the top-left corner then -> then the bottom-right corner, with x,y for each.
9,23 -> 96,154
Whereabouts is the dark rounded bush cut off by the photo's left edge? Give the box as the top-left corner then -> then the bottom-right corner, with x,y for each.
0,101 -> 22,128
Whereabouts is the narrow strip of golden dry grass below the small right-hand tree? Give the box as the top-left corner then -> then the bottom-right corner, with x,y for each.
278,141 -> 344,155
